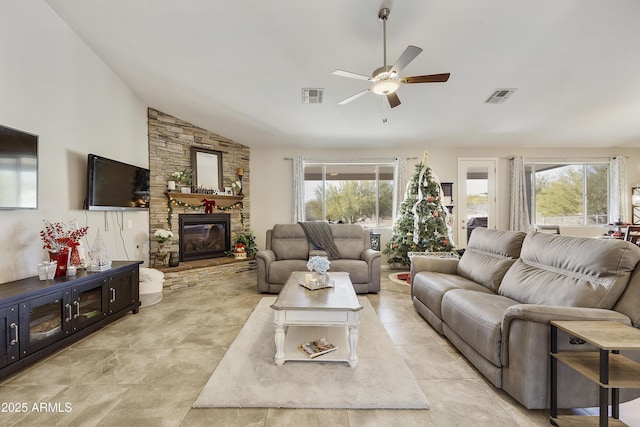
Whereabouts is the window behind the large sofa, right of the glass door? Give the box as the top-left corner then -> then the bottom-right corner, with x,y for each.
525,162 -> 609,225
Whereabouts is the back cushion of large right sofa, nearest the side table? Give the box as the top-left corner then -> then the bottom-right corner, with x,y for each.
499,233 -> 640,309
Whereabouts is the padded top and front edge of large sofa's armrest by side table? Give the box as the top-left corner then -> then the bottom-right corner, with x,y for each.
501,304 -> 631,366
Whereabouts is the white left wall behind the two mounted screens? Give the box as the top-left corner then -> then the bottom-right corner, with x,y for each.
0,0 -> 148,283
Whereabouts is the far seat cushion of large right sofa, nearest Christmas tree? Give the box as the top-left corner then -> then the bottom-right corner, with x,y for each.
411,271 -> 491,319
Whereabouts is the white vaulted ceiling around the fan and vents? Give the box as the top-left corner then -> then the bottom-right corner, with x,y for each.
46,0 -> 640,148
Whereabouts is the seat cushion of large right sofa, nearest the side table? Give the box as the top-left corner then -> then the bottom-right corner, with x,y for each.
442,289 -> 518,366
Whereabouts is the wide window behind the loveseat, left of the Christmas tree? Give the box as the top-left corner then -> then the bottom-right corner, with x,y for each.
304,162 -> 394,227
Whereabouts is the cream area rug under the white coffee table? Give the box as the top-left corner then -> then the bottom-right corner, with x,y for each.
193,297 -> 429,409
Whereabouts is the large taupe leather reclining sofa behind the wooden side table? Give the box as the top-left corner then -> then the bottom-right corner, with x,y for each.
411,228 -> 640,409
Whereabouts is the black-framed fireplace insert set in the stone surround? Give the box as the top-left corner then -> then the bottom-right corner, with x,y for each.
178,214 -> 231,262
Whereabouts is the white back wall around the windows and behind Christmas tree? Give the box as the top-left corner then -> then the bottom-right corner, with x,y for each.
251,142 -> 640,258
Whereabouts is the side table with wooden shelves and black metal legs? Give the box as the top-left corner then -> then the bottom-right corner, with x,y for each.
549,321 -> 640,427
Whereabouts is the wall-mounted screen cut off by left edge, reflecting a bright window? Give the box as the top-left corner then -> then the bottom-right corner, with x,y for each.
0,126 -> 38,209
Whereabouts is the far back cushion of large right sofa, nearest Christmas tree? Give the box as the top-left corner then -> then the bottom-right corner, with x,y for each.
458,228 -> 526,292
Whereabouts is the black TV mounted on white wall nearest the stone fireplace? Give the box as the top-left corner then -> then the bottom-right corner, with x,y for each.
87,154 -> 149,211
